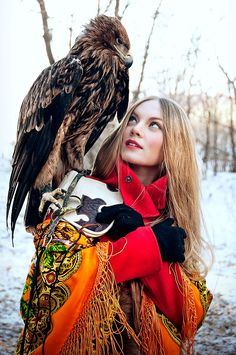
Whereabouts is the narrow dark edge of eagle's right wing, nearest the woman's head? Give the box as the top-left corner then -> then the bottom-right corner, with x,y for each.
85,72 -> 129,154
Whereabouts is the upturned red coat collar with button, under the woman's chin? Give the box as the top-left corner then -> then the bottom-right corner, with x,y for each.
96,161 -> 167,222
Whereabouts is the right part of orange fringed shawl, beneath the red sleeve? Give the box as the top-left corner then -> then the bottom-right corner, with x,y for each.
120,276 -> 212,355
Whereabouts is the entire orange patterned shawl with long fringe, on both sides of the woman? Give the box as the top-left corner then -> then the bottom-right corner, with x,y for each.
16,220 -> 211,355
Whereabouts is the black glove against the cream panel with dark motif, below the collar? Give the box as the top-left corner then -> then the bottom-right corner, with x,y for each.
96,203 -> 144,240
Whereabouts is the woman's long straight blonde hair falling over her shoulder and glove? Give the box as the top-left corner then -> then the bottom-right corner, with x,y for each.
93,96 -> 210,278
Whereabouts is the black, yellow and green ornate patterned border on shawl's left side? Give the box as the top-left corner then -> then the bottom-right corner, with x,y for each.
16,221 -> 92,354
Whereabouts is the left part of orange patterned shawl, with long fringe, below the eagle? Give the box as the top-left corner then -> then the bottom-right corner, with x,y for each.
16,220 -> 139,355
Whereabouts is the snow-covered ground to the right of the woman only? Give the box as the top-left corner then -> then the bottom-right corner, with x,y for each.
196,173 -> 236,355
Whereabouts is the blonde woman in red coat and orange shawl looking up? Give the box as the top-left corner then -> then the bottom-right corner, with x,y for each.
18,97 -> 212,354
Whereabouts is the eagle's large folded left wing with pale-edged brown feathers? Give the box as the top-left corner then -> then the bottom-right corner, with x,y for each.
6,55 -> 82,232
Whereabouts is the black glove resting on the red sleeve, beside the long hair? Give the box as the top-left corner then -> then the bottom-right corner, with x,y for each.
152,218 -> 187,263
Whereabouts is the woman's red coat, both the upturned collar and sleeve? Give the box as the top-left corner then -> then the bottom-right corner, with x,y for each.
93,163 -> 183,326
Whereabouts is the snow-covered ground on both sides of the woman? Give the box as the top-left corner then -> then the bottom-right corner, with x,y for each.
0,157 -> 236,355
